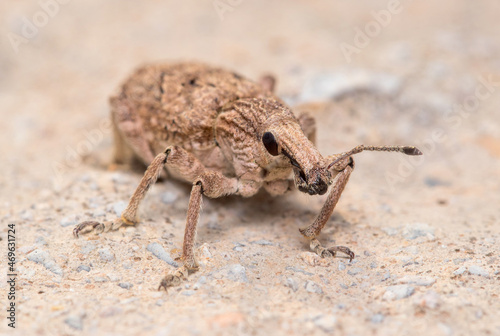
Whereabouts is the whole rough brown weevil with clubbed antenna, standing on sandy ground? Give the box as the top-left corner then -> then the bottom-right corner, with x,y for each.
73,63 -> 422,289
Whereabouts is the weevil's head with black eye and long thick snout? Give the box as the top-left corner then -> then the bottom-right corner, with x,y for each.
259,100 -> 332,195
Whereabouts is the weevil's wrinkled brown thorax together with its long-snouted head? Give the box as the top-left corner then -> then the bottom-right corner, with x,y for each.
214,98 -> 331,195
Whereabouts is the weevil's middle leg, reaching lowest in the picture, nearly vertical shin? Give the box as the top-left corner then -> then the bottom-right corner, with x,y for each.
158,170 -> 238,290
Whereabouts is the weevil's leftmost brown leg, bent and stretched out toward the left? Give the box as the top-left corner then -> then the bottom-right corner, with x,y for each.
73,146 -> 205,237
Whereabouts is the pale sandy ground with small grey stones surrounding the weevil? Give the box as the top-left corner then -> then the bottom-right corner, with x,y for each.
0,0 -> 500,335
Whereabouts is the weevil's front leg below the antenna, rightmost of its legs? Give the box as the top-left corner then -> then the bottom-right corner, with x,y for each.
299,158 -> 354,260
